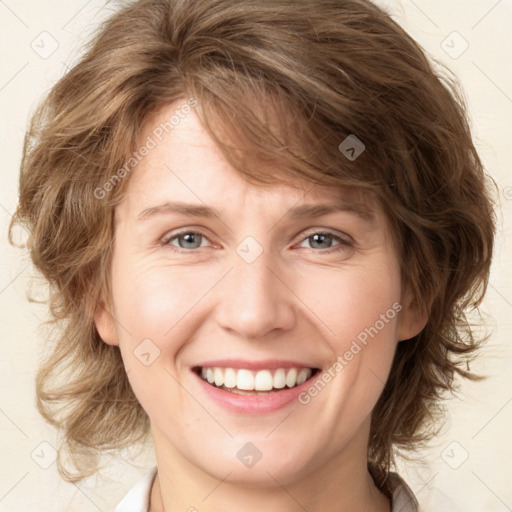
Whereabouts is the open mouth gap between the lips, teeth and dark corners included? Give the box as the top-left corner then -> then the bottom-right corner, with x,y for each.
192,366 -> 320,395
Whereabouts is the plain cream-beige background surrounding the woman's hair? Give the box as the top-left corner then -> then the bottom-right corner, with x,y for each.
0,0 -> 512,512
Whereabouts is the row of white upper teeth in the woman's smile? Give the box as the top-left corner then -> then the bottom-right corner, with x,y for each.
201,367 -> 313,391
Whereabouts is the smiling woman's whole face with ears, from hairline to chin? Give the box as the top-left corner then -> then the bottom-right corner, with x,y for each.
95,102 -> 422,485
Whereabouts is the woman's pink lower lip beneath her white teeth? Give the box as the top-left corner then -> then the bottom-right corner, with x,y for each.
192,371 -> 321,414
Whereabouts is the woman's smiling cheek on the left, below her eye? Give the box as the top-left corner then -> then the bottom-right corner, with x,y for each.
113,258 -> 202,419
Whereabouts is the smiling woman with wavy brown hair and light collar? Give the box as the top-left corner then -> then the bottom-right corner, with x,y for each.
9,0 -> 494,512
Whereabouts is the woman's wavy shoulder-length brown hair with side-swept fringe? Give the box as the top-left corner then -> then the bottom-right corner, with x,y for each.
11,0 -> 495,485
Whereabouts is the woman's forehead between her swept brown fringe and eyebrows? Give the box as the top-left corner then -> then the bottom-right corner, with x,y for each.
118,100 -> 378,222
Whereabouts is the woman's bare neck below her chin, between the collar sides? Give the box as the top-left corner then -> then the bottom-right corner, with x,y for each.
150,431 -> 391,512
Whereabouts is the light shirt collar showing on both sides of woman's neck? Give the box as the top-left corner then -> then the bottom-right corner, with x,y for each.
115,467 -> 419,512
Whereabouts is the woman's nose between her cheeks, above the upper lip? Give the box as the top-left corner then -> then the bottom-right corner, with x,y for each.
217,251 -> 296,340
